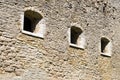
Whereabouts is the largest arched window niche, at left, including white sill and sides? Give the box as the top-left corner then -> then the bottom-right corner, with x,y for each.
22,10 -> 46,38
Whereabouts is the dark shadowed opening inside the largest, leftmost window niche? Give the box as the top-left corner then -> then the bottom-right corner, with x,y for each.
23,10 -> 43,33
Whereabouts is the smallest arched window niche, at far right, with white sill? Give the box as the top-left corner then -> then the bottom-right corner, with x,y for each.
101,37 -> 112,57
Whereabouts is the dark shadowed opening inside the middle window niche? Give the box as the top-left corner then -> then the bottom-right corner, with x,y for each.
71,26 -> 82,44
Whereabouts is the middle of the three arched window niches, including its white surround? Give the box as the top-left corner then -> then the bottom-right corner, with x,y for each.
69,26 -> 85,49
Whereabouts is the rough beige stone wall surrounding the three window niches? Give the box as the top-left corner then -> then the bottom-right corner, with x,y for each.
0,0 -> 120,80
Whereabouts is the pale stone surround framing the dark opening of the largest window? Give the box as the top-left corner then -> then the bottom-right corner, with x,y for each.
21,8 -> 46,39
